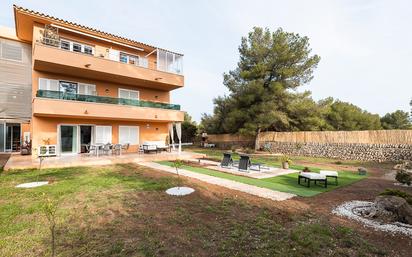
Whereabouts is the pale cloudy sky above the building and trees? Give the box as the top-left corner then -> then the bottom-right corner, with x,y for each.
0,0 -> 412,121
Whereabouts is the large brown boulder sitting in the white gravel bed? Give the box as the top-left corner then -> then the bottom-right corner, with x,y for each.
374,195 -> 412,225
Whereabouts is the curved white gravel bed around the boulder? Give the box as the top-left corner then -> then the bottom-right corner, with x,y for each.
332,201 -> 412,237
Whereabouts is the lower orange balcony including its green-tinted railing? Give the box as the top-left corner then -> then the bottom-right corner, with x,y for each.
33,90 -> 184,122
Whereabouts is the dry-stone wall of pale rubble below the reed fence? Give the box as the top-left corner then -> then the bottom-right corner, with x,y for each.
260,142 -> 412,162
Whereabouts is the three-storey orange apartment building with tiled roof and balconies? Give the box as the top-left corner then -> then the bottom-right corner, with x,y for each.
0,6 -> 184,155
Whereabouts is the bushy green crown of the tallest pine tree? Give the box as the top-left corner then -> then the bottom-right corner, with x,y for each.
208,27 -> 320,147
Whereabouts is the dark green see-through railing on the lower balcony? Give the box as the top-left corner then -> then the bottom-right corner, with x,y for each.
36,90 -> 180,110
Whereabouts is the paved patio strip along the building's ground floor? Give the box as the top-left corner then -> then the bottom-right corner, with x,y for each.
4,152 -> 204,170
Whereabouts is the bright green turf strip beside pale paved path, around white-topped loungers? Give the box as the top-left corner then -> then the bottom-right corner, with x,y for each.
158,161 -> 365,197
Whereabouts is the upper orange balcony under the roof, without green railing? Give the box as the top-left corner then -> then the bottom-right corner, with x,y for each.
33,43 -> 184,91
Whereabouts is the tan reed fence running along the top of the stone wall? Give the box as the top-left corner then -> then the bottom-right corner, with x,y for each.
208,130 -> 412,145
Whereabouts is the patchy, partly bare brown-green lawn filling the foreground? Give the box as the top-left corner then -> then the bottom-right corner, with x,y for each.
0,164 -> 384,256
